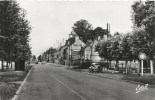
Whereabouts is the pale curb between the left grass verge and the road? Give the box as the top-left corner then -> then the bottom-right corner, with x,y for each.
11,68 -> 32,100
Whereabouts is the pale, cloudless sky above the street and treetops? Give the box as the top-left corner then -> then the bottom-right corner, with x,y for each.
18,0 -> 133,56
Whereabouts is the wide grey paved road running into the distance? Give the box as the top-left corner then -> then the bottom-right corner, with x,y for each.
18,64 -> 155,100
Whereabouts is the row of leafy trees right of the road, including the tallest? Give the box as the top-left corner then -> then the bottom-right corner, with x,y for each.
96,1 -> 155,69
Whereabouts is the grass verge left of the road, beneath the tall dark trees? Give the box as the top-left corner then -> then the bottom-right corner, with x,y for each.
0,66 -> 32,100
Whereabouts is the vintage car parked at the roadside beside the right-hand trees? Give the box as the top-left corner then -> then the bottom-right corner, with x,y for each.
89,63 -> 102,73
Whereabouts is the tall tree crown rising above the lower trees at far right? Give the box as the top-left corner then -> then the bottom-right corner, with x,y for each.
132,1 -> 155,39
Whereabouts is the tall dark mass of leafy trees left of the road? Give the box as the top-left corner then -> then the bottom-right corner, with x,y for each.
0,0 -> 31,70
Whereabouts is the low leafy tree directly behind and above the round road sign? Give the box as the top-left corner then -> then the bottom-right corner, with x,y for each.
131,28 -> 153,59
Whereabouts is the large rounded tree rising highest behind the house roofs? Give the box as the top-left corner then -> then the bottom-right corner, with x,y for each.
72,19 -> 93,43
